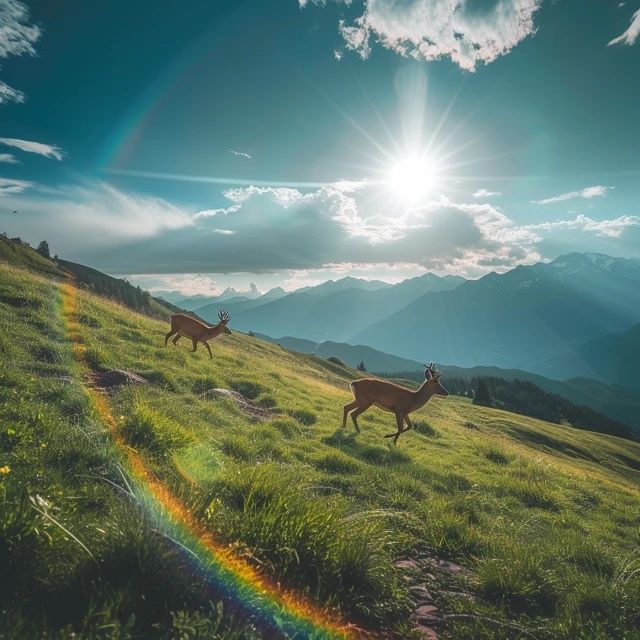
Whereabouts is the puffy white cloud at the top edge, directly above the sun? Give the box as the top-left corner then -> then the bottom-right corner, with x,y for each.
300,0 -> 541,71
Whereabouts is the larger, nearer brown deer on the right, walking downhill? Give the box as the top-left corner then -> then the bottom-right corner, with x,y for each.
342,362 -> 449,444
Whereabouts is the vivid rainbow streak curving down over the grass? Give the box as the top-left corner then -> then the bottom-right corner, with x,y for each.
61,281 -> 366,640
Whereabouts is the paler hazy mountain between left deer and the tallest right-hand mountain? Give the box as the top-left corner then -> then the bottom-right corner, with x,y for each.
225,273 -> 464,342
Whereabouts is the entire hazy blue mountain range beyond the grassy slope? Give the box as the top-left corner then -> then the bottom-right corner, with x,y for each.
169,253 -> 640,389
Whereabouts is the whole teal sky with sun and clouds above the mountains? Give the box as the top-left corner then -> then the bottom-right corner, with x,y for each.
0,0 -> 640,294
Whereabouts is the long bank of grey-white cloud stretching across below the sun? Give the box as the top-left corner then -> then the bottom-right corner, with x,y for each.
4,176 -> 639,276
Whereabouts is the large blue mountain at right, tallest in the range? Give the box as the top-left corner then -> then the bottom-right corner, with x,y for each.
347,253 -> 640,377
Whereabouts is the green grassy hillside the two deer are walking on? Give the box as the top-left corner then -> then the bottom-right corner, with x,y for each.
0,263 -> 640,640
